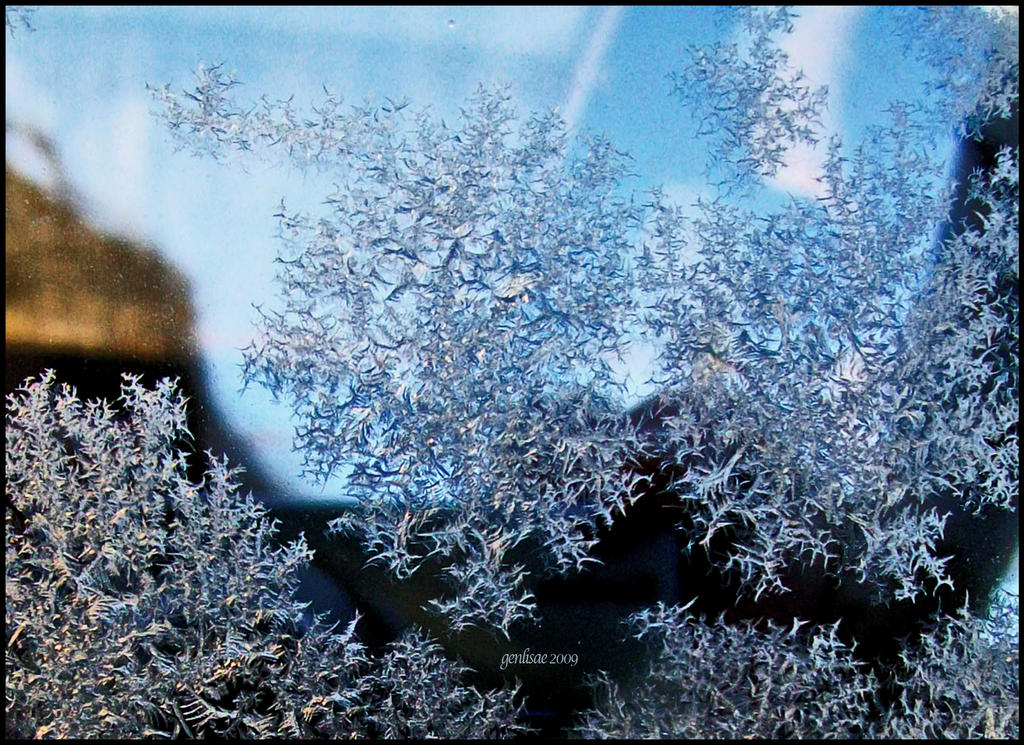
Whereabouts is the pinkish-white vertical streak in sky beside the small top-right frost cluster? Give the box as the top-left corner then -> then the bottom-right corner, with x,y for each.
771,6 -> 862,196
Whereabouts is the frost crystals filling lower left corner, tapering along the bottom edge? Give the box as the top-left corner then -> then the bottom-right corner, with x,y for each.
4,373 -> 519,738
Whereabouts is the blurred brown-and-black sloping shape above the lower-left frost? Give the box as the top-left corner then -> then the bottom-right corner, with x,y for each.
4,122 -> 280,495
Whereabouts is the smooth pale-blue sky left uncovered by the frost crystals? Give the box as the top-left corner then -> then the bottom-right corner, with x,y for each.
5,6 -> 1011,505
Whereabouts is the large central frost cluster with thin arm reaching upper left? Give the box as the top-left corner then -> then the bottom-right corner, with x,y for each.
156,67 -> 640,630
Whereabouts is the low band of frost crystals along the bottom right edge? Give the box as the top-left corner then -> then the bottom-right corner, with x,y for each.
573,605 -> 1020,739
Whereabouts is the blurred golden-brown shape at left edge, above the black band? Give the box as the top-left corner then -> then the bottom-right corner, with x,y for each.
4,127 -> 196,362
